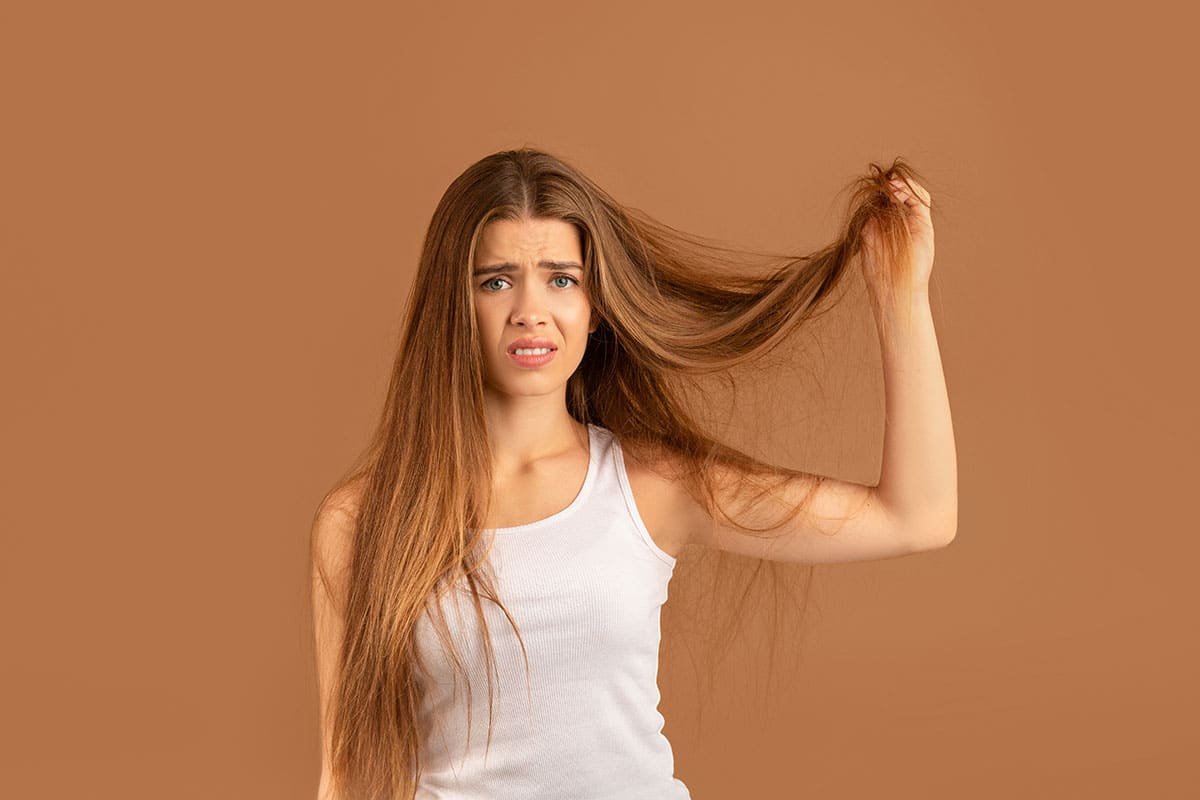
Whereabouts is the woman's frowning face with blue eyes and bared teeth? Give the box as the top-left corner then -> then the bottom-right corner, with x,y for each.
472,219 -> 599,395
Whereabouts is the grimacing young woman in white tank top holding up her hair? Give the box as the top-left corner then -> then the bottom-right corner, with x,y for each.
312,149 -> 958,800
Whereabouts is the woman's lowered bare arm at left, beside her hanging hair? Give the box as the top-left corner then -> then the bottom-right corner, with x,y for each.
310,489 -> 356,800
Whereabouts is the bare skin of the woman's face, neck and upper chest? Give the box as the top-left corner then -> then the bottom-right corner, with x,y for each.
472,214 -> 599,527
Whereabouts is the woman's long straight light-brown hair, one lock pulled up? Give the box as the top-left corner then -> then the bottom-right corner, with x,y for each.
313,148 -> 918,800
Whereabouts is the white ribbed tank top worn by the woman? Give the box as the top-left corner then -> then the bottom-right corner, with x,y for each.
415,425 -> 690,800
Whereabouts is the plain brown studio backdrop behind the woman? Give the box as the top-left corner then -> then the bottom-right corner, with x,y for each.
0,0 -> 1200,800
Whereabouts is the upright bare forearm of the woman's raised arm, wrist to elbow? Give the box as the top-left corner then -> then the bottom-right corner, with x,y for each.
876,290 -> 958,543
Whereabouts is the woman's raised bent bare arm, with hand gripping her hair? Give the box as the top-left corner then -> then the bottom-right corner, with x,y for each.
664,175 -> 958,563
